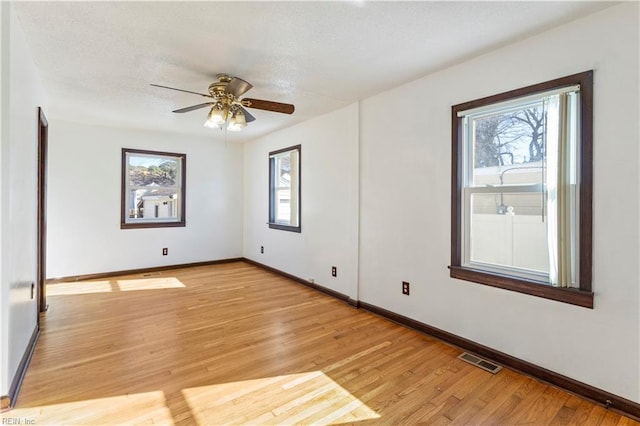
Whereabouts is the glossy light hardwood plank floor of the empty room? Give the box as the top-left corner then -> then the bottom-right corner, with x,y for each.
2,262 -> 638,425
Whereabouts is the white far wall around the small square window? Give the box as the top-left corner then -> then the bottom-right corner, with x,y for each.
47,119 -> 243,278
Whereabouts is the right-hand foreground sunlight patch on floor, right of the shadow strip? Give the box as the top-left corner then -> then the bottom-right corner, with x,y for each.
182,371 -> 380,425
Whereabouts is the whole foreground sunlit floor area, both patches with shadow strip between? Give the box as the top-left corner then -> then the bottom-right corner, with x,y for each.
5,371 -> 380,425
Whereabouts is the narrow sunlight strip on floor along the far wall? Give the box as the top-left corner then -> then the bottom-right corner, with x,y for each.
47,277 -> 185,296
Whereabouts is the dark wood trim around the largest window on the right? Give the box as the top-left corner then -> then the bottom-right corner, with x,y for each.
449,71 -> 593,308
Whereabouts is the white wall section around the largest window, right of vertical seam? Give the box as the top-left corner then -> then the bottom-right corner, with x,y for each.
359,2 -> 640,402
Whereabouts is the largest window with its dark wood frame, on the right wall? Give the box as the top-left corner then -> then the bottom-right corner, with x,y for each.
450,71 -> 593,307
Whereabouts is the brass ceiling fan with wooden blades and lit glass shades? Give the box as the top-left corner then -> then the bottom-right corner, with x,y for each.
151,74 -> 295,131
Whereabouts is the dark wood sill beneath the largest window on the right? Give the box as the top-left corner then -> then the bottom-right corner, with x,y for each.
449,266 -> 593,309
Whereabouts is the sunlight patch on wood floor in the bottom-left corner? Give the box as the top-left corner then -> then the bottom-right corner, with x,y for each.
0,391 -> 174,425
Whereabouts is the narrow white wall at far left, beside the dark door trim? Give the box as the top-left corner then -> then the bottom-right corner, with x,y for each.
0,2 -> 46,395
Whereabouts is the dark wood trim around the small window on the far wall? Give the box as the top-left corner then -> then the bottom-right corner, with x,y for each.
120,148 -> 187,229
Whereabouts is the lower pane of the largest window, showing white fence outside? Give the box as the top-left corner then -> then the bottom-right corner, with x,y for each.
469,192 -> 549,274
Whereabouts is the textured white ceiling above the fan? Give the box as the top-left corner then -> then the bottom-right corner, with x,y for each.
14,0 -> 614,141
